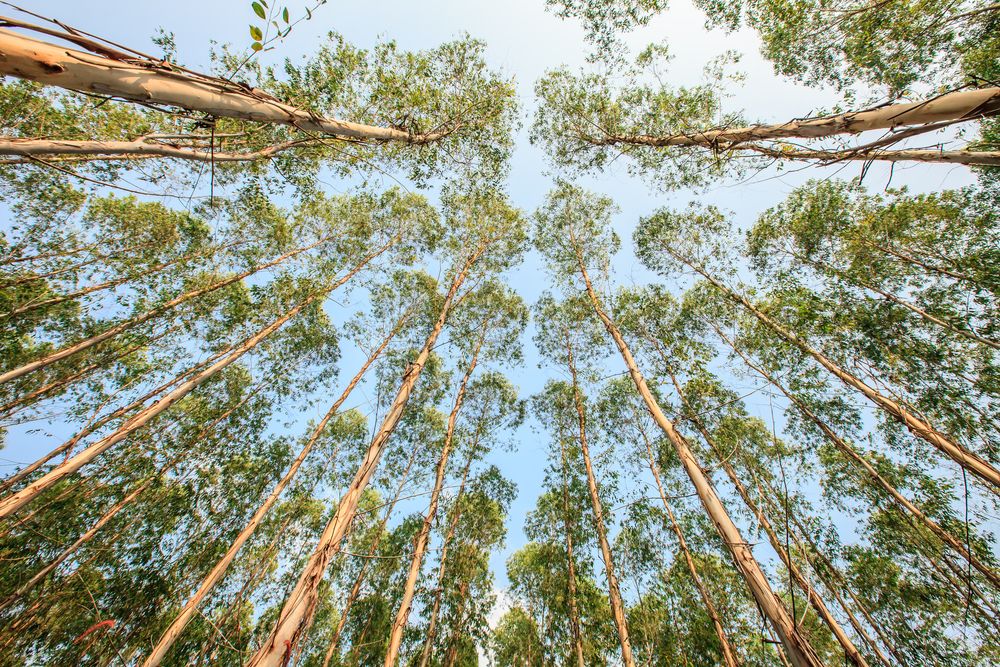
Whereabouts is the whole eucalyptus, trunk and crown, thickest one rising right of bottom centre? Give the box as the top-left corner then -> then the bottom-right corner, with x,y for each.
536,183 -> 822,667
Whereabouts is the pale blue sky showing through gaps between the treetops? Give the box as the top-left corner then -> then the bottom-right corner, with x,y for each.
13,0 -> 984,620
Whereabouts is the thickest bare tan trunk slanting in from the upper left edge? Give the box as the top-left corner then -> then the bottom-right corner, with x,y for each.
0,30 -> 451,144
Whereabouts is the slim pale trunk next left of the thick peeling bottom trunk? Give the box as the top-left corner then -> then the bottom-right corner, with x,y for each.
143,311 -> 412,667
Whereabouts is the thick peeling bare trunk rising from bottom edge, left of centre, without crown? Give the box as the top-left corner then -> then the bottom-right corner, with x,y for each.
248,245 -> 486,667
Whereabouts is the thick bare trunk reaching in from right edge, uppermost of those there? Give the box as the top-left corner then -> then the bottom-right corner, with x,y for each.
584,88 -> 1000,150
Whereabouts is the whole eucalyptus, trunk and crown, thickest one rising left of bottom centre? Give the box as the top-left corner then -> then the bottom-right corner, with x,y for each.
250,191 -> 525,665
